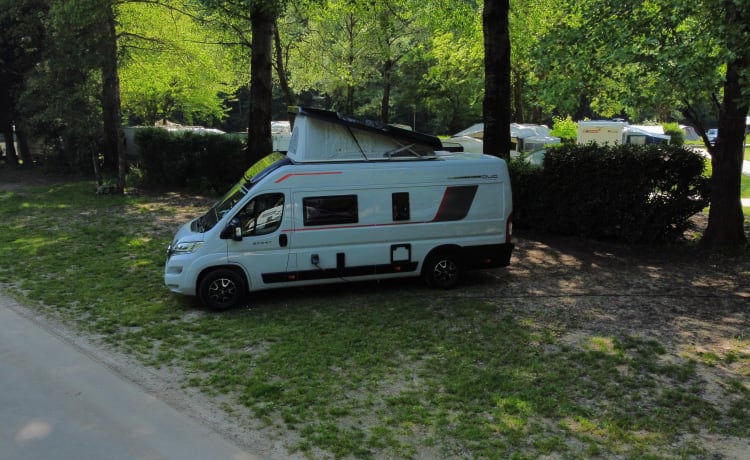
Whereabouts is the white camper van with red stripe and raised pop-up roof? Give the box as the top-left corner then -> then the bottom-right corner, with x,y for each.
164,108 -> 513,310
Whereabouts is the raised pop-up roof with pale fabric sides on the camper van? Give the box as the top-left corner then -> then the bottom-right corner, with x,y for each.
287,107 -> 442,163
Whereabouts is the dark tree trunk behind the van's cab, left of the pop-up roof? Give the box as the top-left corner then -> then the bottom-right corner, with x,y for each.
247,2 -> 275,164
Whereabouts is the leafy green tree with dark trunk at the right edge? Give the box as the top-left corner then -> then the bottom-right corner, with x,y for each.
570,0 -> 750,251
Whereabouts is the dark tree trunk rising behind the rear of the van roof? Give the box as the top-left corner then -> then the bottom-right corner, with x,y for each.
482,0 -> 511,159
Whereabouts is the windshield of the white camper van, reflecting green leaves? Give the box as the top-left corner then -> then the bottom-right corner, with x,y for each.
191,152 -> 292,233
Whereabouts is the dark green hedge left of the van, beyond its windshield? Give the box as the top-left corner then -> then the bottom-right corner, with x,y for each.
135,128 -> 250,193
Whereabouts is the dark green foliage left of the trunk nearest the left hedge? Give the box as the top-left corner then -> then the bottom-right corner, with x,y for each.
18,0 -> 108,173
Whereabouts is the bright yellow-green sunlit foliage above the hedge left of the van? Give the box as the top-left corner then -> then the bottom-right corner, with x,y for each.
118,2 -> 241,125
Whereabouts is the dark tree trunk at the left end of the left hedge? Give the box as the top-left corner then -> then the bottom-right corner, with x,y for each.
102,3 -> 128,193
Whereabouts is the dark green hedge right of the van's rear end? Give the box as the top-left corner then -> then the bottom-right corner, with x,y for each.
510,144 -> 708,244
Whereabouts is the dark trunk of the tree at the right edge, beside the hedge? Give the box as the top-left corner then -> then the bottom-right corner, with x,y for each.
700,58 -> 748,252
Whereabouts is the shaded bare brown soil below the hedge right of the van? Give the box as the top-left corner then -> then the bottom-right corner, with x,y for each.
488,227 -> 750,460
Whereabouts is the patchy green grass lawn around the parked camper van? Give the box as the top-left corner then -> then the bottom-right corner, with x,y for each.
0,178 -> 750,459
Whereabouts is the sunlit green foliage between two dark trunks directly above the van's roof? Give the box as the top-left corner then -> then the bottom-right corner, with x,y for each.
279,0 -> 483,133
